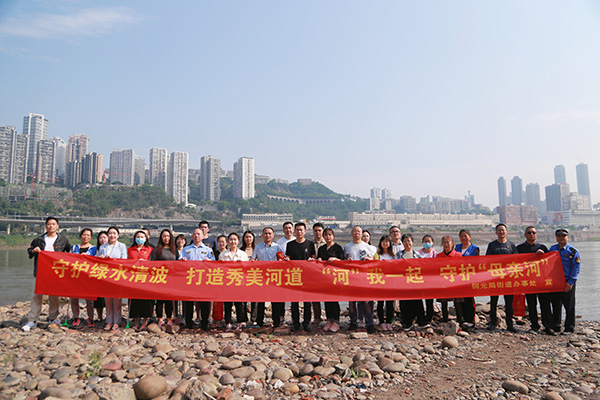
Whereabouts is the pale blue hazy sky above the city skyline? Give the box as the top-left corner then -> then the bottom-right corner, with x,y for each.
0,0 -> 600,208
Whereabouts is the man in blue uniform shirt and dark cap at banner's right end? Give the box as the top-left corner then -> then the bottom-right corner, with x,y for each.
550,229 -> 581,335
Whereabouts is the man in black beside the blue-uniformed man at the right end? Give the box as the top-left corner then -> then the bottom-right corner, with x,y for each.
517,226 -> 554,335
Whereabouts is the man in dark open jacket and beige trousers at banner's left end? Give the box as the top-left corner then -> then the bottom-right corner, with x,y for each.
21,217 -> 71,332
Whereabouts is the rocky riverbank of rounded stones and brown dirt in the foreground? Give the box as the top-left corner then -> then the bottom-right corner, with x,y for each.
0,303 -> 600,400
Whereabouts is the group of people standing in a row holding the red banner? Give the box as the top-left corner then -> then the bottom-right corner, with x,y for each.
22,217 -> 581,335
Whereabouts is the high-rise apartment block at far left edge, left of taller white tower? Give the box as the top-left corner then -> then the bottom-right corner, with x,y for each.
0,126 -> 29,184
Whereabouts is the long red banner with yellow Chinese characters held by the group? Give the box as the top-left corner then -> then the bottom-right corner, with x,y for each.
36,251 -> 565,302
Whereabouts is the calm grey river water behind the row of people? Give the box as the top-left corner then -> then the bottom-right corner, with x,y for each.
0,242 -> 600,321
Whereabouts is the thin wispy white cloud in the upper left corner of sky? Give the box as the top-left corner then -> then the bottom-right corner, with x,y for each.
0,7 -> 147,39
